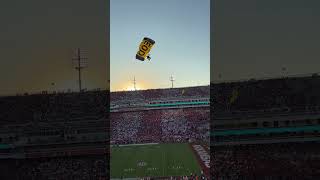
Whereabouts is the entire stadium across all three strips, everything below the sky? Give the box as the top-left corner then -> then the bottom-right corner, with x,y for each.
0,74 -> 320,180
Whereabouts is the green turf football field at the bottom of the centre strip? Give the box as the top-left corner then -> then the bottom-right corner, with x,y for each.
110,144 -> 201,178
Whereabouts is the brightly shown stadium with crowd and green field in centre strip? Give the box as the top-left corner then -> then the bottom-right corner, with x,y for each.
110,86 -> 210,179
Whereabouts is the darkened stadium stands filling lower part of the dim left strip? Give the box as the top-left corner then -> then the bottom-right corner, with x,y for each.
0,89 -> 109,180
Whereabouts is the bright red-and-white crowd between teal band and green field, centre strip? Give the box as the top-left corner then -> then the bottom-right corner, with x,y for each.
110,108 -> 210,144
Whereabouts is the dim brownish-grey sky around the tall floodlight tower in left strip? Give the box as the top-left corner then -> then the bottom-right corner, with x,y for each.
0,0 -> 109,96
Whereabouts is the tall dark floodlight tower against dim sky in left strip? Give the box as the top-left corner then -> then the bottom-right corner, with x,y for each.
72,48 -> 88,92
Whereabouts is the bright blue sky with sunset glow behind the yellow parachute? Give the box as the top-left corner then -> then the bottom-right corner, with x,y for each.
110,0 -> 210,91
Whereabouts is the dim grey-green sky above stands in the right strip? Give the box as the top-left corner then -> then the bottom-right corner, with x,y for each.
211,0 -> 320,81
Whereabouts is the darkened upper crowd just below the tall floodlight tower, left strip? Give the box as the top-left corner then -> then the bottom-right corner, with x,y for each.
0,91 -> 109,143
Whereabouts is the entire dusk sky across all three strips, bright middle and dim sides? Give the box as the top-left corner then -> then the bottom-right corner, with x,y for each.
0,0 -> 320,95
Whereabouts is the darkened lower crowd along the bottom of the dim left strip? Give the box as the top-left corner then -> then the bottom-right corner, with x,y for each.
11,156 -> 108,180
